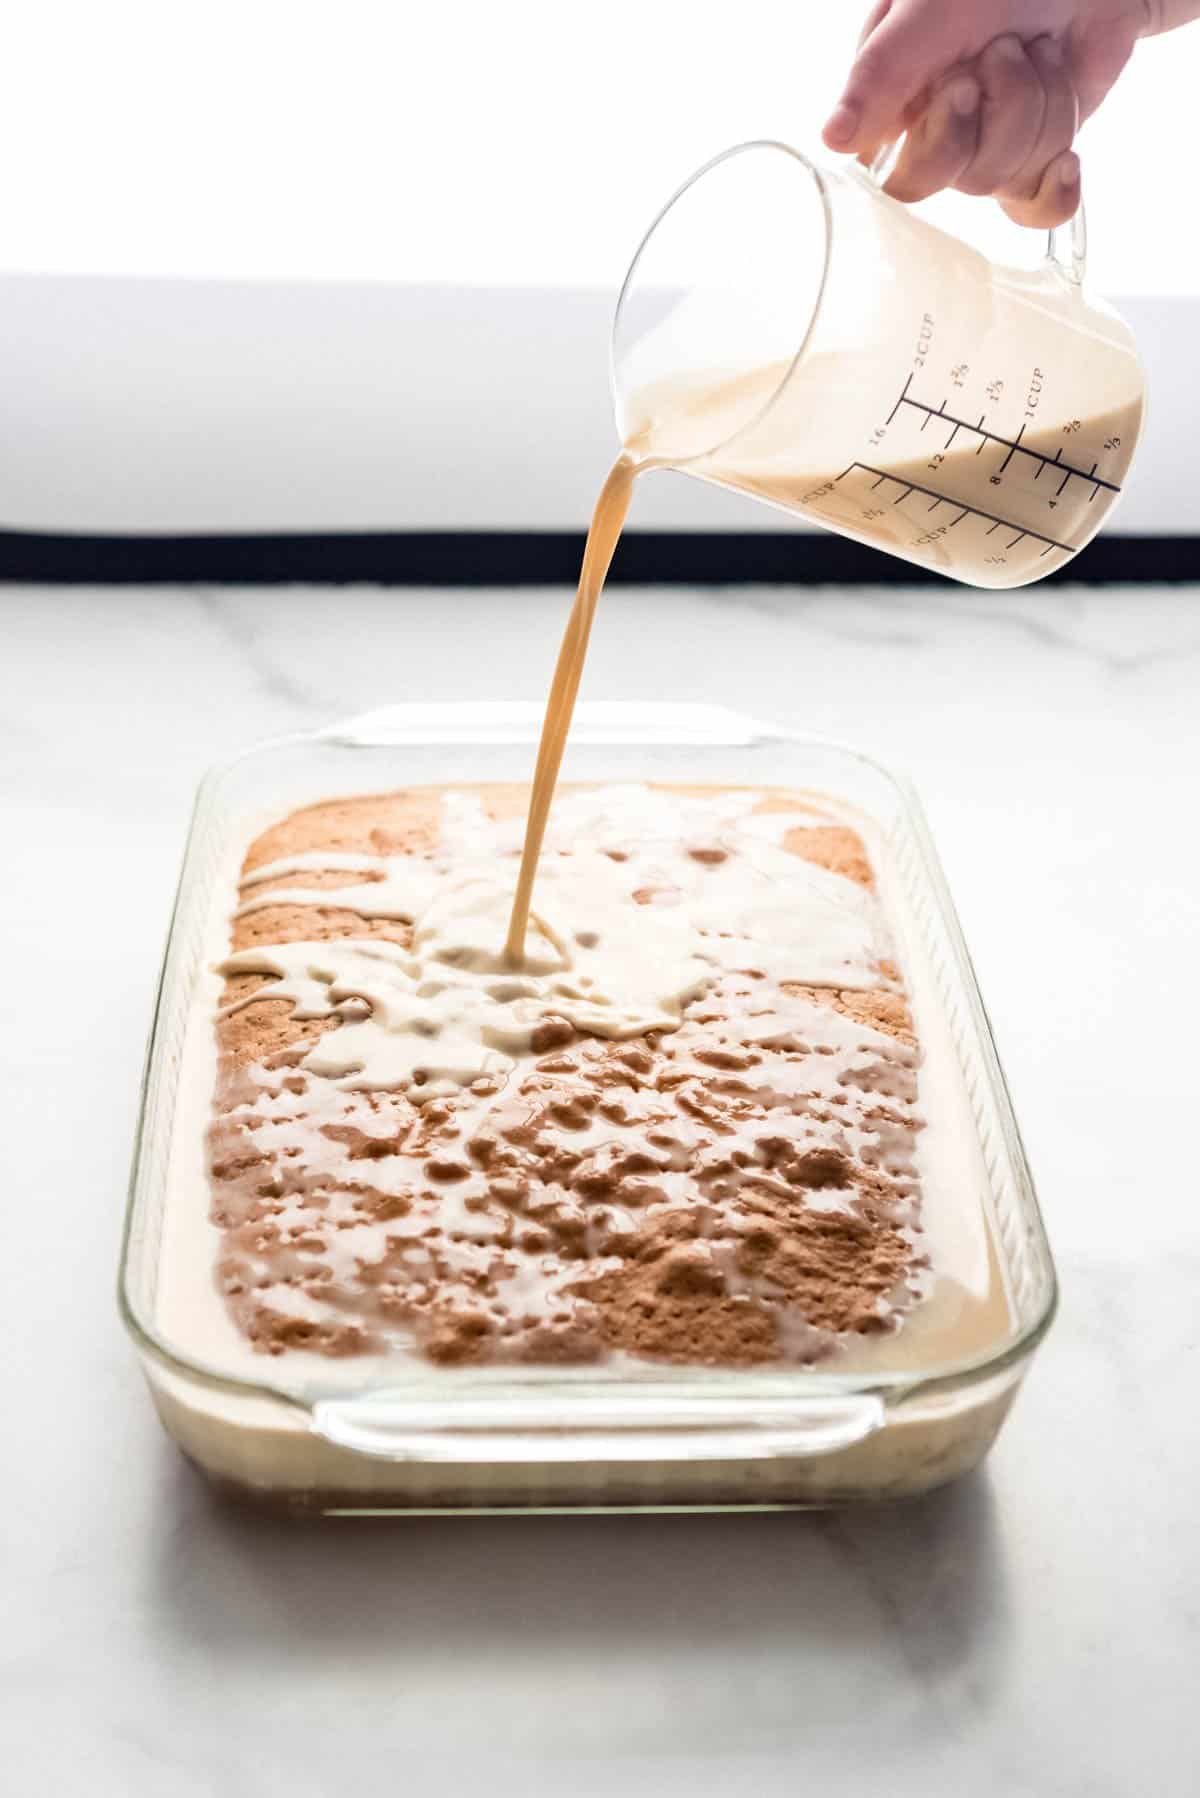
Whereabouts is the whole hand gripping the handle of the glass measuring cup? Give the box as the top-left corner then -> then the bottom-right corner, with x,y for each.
824,0 -> 1151,227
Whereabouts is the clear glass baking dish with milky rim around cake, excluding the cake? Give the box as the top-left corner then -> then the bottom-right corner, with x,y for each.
121,705 -> 1056,1516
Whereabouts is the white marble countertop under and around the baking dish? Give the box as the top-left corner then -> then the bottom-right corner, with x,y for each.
0,586 -> 1200,1798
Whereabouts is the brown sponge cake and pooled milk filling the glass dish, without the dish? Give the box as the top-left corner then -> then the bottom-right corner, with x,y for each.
188,786 -> 1011,1372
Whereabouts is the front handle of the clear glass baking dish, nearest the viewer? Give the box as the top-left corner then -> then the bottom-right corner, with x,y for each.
311,1392 -> 885,1465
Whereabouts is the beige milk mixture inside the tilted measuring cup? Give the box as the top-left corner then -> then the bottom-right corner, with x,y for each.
628,338 -> 1142,586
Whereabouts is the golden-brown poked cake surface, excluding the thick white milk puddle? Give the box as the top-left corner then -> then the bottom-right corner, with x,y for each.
210,788 -> 925,1366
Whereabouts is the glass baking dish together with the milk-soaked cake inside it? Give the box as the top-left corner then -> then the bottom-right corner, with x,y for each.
121,705 -> 1054,1516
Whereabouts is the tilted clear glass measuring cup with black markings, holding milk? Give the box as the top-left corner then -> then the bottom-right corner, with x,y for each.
612,140 -> 1144,586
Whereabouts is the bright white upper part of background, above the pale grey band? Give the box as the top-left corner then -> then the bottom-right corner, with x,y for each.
0,0 -> 1200,293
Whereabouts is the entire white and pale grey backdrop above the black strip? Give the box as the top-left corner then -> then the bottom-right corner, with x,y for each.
0,0 -> 1200,530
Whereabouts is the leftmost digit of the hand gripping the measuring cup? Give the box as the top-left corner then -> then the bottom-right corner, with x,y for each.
822,0 -> 964,151
